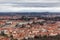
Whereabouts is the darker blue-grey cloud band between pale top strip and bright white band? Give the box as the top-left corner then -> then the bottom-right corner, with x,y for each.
0,3 -> 60,7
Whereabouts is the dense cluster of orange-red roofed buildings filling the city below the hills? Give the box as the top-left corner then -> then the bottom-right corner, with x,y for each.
0,17 -> 60,40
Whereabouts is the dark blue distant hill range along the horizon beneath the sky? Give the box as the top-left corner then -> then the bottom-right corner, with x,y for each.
0,12 -> 60,16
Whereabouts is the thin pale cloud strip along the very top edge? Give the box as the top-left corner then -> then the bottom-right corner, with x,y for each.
0,0 -> 60,2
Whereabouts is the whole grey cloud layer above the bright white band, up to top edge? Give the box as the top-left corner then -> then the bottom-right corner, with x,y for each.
0,0 -> 60,7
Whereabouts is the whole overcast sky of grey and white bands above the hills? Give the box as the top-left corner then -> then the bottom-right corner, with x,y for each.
0,0 -> 60,12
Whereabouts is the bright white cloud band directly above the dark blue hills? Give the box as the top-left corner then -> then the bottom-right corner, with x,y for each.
0,6 -> 60,12
